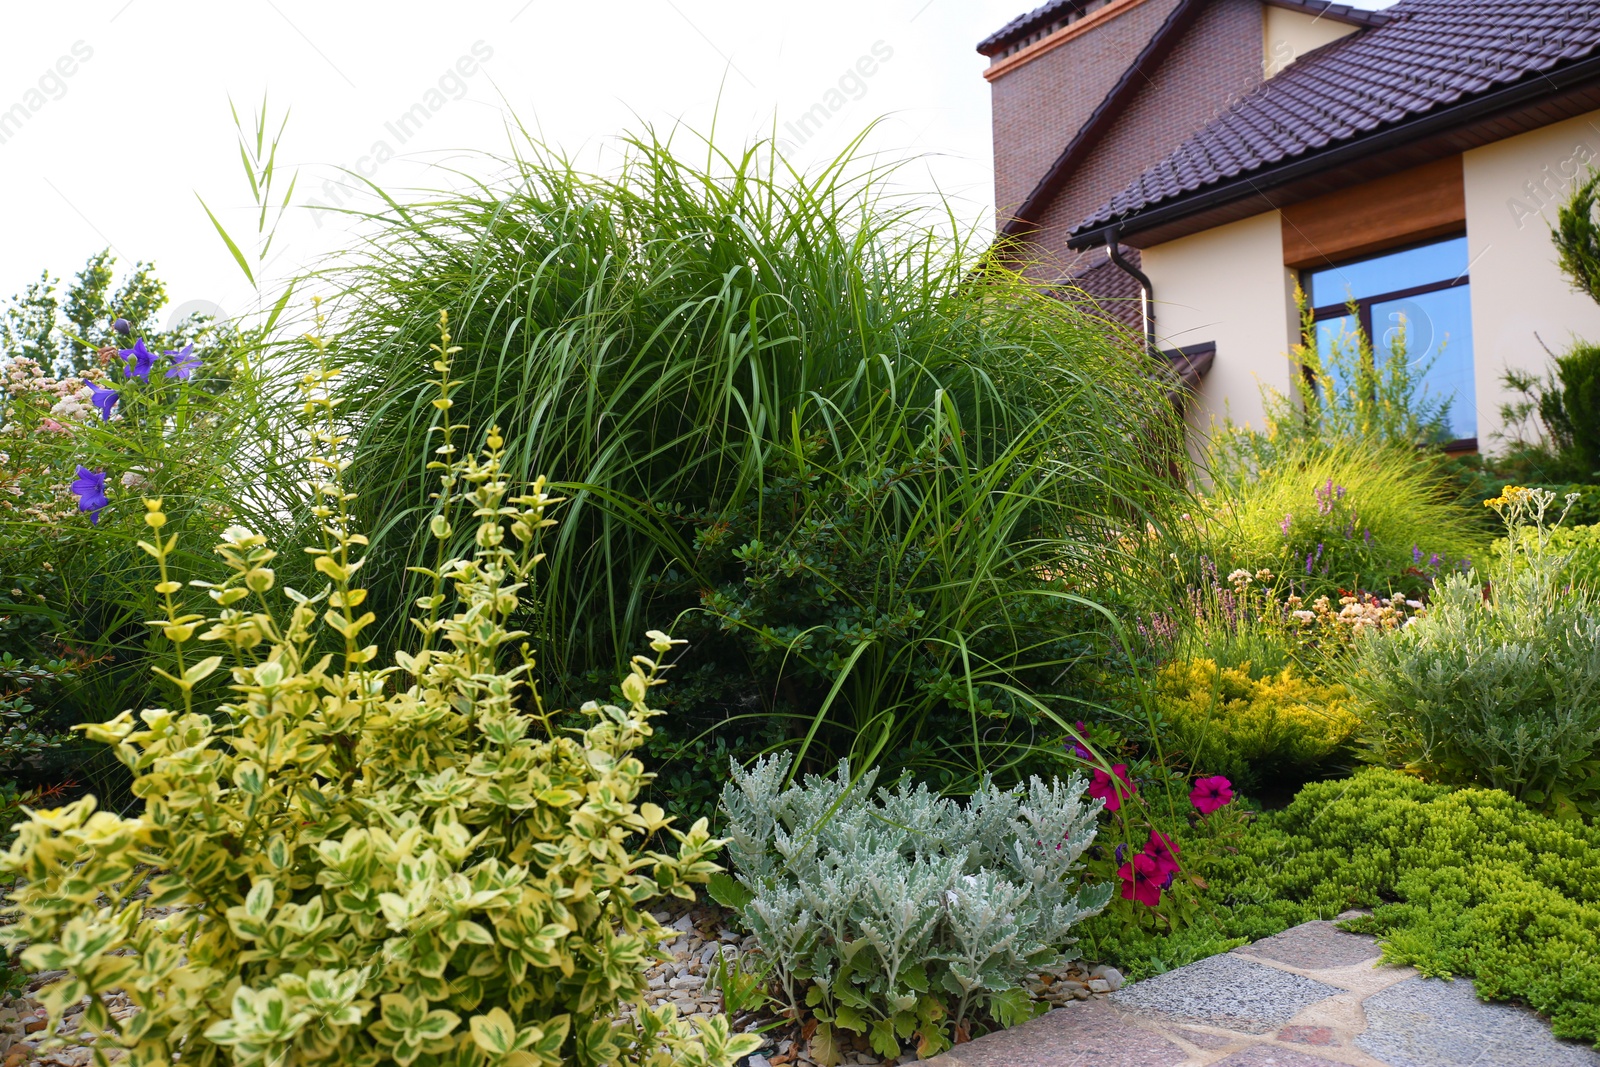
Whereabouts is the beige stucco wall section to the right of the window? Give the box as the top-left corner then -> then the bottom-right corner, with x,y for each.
1465,112 -> 1600,451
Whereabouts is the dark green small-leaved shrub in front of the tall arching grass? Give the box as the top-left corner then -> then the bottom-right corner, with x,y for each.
662,440 -> 1102,787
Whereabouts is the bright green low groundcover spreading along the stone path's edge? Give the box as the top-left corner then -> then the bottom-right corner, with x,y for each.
1082,768 -> 1600,1046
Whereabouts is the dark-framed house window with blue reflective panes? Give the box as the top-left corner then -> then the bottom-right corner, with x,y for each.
1306,237 -> 1478,448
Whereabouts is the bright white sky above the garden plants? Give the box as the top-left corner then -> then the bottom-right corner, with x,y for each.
0,0 -> 1387,327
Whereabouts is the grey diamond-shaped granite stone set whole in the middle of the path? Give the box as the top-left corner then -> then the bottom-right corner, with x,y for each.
1109,953 -> 1342,1033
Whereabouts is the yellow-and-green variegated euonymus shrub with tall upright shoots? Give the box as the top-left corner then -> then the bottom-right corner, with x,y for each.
0,316 -> 755,1067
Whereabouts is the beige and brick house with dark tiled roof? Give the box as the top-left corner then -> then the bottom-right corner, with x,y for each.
979,0 -> 1600,451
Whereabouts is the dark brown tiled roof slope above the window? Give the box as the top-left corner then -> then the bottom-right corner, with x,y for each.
1074,0 -> 1600,235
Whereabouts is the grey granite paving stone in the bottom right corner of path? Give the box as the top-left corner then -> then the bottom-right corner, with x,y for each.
1355,977 -> 1600,1067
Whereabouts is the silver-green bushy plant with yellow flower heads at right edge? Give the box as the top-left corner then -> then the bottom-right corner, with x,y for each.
1350,486 -> 1600,813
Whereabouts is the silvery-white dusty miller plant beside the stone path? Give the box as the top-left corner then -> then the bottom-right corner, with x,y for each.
722,755 -> 1110,1062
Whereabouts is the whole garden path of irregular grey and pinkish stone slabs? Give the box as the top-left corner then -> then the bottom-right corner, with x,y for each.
928,923 -> 1600,1067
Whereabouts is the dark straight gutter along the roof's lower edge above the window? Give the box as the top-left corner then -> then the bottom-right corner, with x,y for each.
1067,54 -> 1600,251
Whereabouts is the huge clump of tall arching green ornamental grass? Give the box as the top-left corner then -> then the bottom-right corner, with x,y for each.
315,130 -> 1184,785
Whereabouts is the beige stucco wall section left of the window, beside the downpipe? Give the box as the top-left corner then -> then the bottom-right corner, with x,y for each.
1144,211 -> 1294,460
